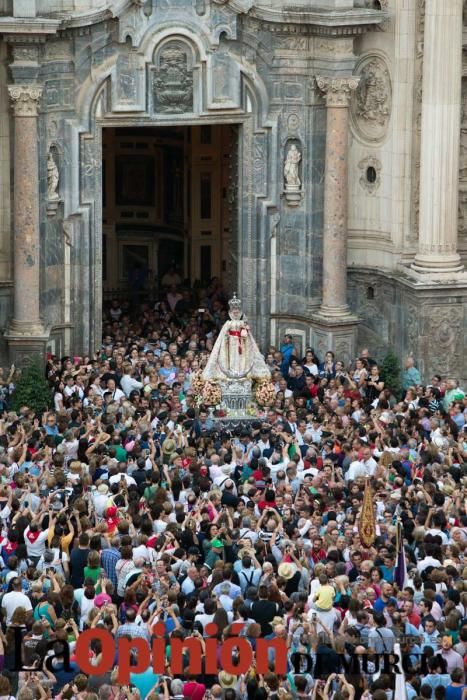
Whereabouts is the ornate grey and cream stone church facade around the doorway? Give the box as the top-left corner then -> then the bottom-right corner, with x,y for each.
0,0 -> 467,378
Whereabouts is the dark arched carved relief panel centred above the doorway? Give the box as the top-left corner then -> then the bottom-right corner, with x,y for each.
154,41 -> 193,114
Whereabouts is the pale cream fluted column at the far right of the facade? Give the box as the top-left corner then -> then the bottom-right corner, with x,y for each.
413,0 -> 463,273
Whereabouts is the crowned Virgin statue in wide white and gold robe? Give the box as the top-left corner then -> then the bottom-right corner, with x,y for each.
202,294 -> 271,382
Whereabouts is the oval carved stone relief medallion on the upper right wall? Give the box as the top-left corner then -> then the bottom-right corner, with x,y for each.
352,56 -> 392,141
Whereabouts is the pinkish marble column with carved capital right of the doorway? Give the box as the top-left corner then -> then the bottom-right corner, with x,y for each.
317,76 -> 359,319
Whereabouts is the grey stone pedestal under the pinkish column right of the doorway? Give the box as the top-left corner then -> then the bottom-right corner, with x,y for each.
311,307 -> 359,364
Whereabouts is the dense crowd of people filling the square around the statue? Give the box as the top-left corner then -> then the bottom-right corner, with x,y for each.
0,280 -> 467,700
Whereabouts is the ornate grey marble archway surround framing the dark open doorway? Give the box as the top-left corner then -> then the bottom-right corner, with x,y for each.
63,21 -> 278,352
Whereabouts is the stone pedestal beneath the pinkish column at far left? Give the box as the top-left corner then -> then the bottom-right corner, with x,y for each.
4,319 -> 49,367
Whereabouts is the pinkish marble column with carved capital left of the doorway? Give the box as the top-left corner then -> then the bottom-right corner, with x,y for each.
8,85 -> 42,334
